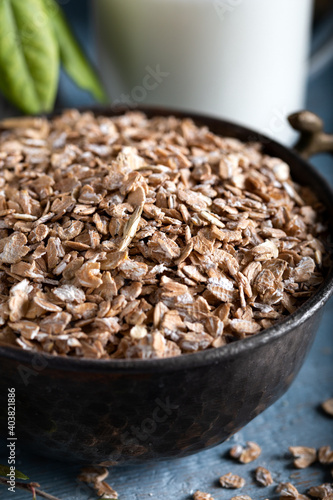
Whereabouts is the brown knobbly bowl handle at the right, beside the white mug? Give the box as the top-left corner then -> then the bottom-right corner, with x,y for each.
288,111 -> 333,158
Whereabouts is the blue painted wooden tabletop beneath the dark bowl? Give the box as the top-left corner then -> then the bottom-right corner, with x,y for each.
0,0 -> 333,500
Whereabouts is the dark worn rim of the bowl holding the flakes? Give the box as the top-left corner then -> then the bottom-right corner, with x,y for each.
0,106 -> 333,373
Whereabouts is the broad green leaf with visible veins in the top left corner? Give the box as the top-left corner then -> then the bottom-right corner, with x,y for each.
0,0 -> 59,113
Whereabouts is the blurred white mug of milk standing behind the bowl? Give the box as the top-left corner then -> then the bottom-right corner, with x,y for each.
92,0 -> 312,142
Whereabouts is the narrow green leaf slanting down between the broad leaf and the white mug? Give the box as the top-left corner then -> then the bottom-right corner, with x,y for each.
44,0 -> 107,102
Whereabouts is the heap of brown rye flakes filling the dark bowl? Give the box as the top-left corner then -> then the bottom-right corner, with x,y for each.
0,110 -> 330,360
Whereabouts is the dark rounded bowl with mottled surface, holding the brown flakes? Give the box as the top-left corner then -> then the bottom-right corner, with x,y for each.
0,109 -> 333,464
